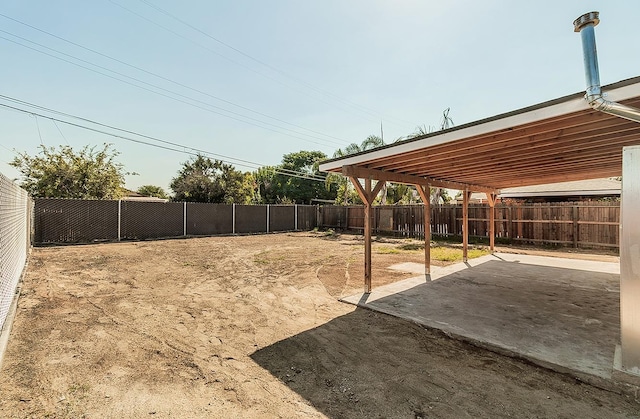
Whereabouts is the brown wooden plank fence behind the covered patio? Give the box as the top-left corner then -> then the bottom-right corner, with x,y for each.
320,202 -> 620,248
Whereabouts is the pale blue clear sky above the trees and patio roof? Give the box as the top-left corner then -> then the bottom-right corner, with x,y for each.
0,0 -> 640,189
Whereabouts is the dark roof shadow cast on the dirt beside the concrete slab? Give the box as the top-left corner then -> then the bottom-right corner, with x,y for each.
251,309 -> 604,418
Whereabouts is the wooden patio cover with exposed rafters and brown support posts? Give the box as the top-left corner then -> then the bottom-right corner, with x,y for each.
320,77 -> 640,292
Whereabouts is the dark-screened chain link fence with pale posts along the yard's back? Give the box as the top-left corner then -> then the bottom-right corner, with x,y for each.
35,198 -> 318,244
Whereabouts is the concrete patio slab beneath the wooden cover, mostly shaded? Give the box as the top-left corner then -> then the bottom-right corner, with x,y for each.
342,253 -> 620,379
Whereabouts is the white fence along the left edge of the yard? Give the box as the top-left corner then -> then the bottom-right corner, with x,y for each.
0,173 -> 33,330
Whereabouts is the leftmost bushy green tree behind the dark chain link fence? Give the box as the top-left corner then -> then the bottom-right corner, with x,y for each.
9,144 -> 127,199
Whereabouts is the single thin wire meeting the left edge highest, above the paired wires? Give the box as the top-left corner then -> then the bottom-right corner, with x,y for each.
0,13 -> 348,145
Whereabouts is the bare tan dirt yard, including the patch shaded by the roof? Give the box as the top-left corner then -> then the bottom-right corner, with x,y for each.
0,233 -> 640,418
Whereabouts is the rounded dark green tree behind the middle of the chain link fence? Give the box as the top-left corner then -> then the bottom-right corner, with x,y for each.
170,155 -> 253,204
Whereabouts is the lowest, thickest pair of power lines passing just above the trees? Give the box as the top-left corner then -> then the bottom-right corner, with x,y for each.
0,99 -> 326,182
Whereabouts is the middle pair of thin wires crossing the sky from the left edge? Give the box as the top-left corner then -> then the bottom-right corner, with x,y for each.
0,29 -> 337,151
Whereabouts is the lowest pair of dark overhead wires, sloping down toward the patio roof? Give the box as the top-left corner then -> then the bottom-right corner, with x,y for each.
0,100 -> 326,182
